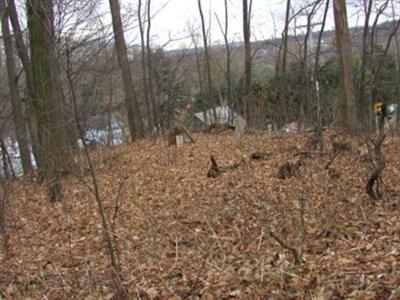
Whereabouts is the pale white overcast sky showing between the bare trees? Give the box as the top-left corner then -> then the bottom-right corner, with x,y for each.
114,0 -> 400,49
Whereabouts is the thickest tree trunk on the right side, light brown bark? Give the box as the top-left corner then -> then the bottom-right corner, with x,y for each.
333,0 -> 359,133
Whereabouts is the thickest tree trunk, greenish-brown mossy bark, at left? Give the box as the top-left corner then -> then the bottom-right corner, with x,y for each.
26,0 -> 72,201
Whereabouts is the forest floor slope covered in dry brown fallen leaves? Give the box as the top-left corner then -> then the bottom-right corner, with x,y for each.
0,132 -> 400,300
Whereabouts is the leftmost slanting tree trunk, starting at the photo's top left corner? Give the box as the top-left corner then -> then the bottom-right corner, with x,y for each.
0,0 -> 33,174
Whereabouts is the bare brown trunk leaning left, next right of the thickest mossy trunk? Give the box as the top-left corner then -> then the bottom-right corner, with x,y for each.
109,0 -> 144,140
